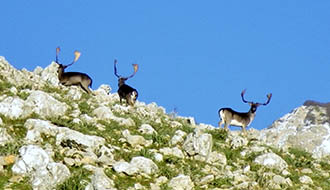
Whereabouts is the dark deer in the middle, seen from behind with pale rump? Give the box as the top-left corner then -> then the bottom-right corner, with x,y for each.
114,59 -> 138,106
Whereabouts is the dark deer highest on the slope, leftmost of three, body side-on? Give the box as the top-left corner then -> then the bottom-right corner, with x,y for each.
55,47 -> 92,94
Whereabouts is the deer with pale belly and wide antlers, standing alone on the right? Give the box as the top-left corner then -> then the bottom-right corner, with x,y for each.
218,89 -> 272,133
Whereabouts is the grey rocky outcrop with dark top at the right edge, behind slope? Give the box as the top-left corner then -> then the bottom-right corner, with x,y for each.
260,105 -> 330,158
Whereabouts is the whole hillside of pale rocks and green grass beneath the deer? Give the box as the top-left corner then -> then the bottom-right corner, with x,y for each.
0,57 -> 330,190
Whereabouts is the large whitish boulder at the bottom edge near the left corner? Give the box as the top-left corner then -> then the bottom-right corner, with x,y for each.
12,145 -> 70,190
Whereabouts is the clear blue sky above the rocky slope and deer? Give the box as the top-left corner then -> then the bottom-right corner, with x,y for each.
0,0 -> 330,129
